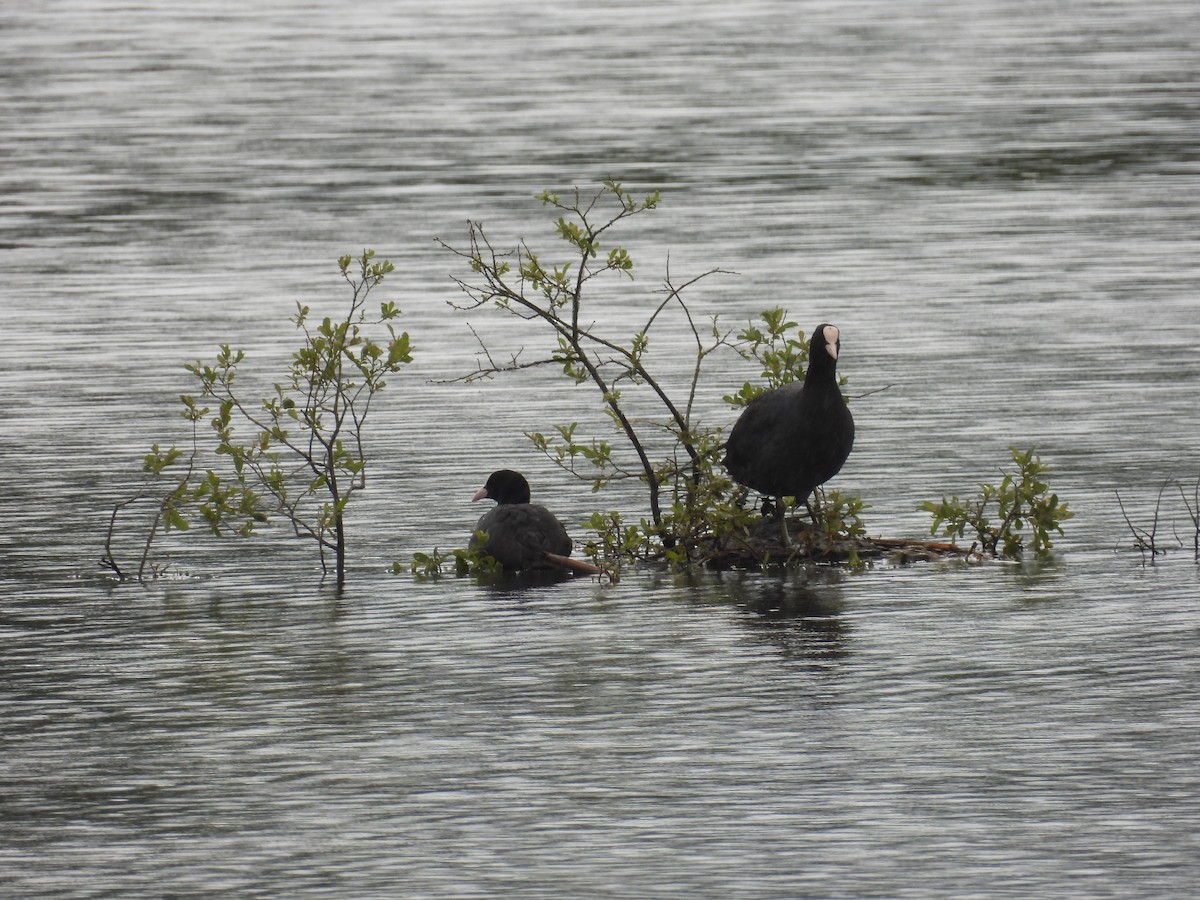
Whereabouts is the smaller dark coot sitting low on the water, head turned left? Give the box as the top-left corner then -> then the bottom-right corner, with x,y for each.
470,469 -> 571,571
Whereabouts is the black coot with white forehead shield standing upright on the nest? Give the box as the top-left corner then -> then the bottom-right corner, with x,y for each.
725,324 -> 854,514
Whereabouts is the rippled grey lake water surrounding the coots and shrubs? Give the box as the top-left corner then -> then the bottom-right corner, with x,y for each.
0,0 -> 1200,898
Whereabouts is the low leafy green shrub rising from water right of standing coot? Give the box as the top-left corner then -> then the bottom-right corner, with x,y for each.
918,446 -> 1075,559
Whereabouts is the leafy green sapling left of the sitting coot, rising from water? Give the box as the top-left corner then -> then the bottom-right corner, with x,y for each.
104,250 -> 412,587
